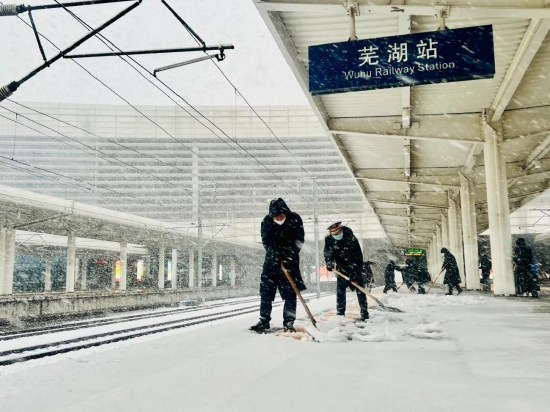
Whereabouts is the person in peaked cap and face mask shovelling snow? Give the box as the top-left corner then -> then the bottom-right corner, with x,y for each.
324,222 -> 369,321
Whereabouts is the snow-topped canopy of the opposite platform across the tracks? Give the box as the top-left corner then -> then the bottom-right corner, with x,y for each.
0,185 -> 196,253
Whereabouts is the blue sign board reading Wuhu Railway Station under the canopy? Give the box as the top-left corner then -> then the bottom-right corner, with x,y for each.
309,25 -> 495,95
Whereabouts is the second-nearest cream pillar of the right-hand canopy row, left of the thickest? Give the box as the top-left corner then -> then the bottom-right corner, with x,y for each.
460,175 -> 480,290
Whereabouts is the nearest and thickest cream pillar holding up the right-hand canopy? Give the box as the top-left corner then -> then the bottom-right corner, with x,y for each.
483,119 -> 516,296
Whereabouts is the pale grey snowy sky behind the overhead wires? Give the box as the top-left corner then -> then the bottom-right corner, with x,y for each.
0,0 -> 307,106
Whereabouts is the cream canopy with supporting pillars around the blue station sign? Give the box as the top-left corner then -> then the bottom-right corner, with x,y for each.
253,0 -> 550,295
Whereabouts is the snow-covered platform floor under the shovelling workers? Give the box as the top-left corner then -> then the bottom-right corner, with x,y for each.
0,290 -> 550,412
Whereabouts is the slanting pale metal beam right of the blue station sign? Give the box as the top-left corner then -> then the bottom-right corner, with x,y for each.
491,18 -> 550,122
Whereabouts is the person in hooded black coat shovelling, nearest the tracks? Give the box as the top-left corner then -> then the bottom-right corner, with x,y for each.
250,198 -> 306,332
